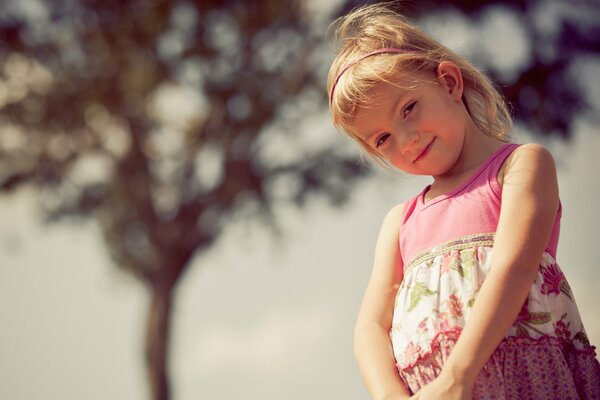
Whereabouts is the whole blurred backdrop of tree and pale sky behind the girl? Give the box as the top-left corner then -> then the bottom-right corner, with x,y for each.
0,0 -> 600,400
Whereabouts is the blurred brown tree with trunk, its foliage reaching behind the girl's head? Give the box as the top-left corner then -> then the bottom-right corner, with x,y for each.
0,0 -> 599,400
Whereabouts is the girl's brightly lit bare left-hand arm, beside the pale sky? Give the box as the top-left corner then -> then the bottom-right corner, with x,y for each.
354,204 -> 409,400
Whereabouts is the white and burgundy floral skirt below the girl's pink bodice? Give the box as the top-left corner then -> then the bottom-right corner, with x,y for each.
390,234 -> 600,400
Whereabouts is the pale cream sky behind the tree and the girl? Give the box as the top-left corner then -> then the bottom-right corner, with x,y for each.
0,2 -> 600,400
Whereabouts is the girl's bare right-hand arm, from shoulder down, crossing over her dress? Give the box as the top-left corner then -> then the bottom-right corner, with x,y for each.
415,144 -> 559,399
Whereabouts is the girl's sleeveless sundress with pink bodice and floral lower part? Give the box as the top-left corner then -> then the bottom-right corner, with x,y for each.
390,144 -> 600,400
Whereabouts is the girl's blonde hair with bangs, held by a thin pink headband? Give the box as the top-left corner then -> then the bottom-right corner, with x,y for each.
327,4 -> 512,164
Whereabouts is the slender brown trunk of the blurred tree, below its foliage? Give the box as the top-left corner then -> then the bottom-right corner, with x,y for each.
145,285 -> 173,400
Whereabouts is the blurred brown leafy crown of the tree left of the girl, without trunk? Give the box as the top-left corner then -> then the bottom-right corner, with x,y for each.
0,1 -> 359,282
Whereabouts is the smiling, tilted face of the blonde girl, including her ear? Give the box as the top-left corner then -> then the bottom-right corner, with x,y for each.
353,62 -> 469,177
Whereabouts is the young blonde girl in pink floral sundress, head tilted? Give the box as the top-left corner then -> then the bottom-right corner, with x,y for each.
328,5 -> 600,400
